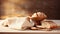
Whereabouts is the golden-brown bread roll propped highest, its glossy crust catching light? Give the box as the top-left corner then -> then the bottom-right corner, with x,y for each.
31,12 -> 47,21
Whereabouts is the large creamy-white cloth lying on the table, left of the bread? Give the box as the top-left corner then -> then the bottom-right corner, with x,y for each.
0,17 -> 34,30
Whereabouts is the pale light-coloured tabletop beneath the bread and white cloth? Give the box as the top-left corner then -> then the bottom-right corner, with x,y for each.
0,20 -> 60,34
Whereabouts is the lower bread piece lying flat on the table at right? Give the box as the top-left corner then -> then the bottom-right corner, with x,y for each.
41,21 -> 57,29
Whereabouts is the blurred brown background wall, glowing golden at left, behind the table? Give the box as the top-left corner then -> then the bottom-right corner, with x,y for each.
0,0 -> 60,19
